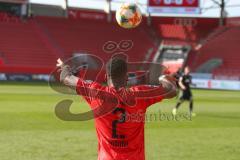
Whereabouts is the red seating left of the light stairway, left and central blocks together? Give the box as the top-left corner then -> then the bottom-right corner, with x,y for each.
0,9 -> 156,73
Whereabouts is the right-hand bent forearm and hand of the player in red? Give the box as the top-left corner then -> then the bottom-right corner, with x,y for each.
159,75 -> 177,99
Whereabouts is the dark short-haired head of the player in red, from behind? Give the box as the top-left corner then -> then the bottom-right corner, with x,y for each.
106,57 -> 127,80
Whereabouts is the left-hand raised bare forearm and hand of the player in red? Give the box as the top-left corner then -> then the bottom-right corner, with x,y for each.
56,58 -> 79,87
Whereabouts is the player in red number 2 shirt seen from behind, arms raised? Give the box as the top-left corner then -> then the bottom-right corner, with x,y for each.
57,58 -> 176,160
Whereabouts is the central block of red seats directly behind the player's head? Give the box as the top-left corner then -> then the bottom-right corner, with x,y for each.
36,17 -> 154,61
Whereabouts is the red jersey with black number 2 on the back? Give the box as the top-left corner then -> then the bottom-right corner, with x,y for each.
76,79 -> 162,160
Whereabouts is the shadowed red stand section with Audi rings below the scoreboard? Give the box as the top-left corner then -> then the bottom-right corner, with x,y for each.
153,17 -> 218,70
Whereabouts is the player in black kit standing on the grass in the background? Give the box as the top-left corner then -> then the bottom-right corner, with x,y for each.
172,66 -> 196,116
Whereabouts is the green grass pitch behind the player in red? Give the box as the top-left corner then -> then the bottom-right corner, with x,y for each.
0,84 -> 240,160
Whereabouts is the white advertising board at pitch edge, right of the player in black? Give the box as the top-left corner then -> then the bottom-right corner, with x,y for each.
192,79 -> 240,90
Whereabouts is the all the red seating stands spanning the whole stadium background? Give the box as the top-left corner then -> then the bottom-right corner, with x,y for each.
0,10 -> 240,79
